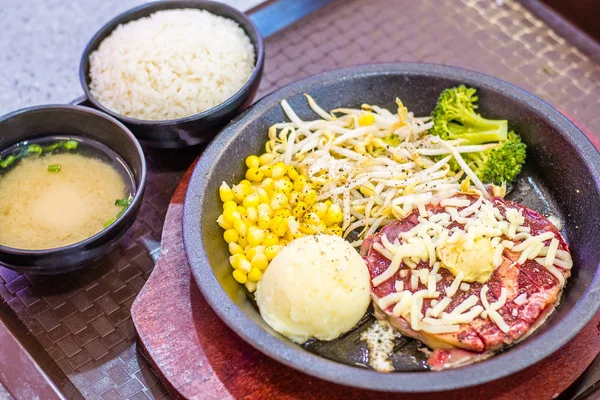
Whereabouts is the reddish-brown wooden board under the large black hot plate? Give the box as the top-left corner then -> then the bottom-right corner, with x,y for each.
131,117 -> 600,400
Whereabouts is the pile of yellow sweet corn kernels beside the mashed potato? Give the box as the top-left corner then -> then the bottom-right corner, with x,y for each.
217,153 -> 343,292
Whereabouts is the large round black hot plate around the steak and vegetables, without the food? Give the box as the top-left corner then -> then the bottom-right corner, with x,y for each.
183,64 -> 600,392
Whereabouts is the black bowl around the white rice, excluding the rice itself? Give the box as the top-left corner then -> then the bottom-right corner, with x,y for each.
79,0 -> 265,148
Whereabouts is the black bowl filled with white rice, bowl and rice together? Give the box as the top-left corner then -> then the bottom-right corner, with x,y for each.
79,0 -> 264,148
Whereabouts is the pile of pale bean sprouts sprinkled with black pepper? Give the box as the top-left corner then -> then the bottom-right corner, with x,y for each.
266,94 -> 497,246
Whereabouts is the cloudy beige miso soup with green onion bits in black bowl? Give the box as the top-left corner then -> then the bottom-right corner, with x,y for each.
0,136 -> 135,250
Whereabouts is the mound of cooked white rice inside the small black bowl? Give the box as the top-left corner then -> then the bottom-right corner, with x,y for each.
90,9 -> 255,120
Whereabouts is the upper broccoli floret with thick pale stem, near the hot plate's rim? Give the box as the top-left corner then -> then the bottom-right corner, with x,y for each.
429,85 -> 508,144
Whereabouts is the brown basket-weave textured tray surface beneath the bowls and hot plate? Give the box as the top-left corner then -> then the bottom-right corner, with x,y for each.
0,0 -> 600,400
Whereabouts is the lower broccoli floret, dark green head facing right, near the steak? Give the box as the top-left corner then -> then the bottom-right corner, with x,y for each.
460,131 -> 527,185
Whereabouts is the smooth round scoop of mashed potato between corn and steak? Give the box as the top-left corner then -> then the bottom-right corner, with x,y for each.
256,235 -> 371,343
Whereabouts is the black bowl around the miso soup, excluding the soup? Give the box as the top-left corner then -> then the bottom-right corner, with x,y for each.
0,105 -> 146,275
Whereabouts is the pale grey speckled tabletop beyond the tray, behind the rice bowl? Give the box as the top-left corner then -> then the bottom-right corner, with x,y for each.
0,0 -> 262,114
